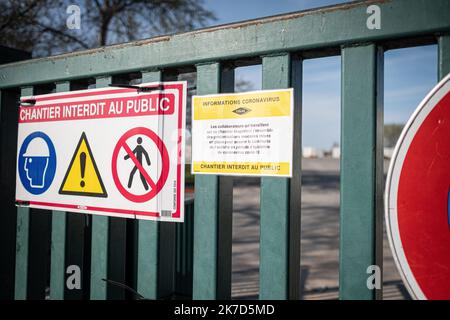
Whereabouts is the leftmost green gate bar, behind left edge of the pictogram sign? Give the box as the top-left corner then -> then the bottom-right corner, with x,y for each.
14,87 -> 33,300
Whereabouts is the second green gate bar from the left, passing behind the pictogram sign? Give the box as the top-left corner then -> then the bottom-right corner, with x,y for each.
50,82 -> 70,300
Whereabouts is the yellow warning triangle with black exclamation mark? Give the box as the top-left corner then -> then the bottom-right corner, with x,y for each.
59,132 -> 108,198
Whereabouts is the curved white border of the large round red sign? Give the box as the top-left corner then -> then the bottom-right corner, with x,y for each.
384,74 -> 450,300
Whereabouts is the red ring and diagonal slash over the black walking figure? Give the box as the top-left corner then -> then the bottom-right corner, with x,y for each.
112,127 -> 170,202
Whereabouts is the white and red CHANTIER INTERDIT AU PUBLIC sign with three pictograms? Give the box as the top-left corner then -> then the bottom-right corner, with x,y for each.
16,82 -> 187,222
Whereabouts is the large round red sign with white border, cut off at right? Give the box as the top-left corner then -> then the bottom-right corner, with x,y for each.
385,74 -> 450,299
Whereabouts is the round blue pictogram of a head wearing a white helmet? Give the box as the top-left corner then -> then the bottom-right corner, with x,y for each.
18,131 -> 56,195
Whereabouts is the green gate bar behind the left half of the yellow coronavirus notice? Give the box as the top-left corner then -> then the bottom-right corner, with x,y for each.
193,62 -> 233,299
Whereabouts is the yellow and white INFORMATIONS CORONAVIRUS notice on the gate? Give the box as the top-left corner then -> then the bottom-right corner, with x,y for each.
191,89 -> 294,177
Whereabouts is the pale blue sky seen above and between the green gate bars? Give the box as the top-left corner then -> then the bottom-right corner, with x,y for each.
201,0 -> 437,149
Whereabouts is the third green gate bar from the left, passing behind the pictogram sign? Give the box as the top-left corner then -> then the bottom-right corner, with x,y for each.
90,77 -> 112,300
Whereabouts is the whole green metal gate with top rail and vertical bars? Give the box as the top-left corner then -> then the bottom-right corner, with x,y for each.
0,0 -> 450,299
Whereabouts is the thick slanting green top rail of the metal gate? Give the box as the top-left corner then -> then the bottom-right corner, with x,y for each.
0,0 -> 450,88
